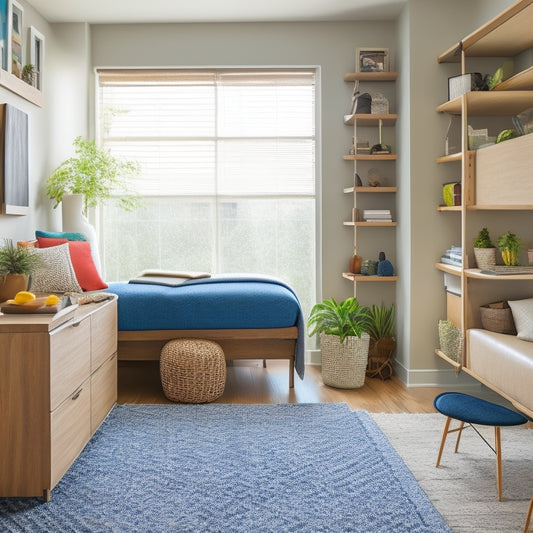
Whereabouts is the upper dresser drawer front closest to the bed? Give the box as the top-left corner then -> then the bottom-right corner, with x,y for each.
91,300 -> 118,372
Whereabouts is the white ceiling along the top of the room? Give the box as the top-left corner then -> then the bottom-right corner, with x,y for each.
29,0 -> 407,24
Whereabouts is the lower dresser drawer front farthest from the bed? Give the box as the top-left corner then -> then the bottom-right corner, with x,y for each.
50,380 -> 91,488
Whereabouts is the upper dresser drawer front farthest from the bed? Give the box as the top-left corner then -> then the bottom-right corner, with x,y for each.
50,318 -> 91,411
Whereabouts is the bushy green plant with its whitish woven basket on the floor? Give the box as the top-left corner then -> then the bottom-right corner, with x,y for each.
307,297 -> 370,389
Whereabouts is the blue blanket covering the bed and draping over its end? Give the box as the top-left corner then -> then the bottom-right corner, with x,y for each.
108,275 -> 305,379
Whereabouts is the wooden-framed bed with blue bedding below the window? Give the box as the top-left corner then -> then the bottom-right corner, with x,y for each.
108,275 -> 305,388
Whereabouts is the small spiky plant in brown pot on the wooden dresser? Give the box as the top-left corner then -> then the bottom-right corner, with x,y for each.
0,240 -> 42,302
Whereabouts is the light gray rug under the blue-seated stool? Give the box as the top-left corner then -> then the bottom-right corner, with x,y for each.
371,413 -> 533,533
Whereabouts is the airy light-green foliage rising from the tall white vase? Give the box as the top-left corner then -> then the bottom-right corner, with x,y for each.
46,137 -> 140,216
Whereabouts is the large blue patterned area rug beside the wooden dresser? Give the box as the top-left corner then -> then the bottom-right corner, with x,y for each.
0,404 -> 451,533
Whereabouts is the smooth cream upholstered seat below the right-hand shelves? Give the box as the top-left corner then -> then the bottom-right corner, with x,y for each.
467,329 -> 533,416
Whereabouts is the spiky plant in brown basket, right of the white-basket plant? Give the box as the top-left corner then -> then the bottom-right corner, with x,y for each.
364,303 -> 396,379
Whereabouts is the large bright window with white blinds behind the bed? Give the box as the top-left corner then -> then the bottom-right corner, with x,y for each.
98,69 -> 316,310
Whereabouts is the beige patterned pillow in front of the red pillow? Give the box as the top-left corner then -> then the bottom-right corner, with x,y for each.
30,243 -> 82,292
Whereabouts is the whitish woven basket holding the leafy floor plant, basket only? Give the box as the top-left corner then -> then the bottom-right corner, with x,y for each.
320,333 -> 370,389
